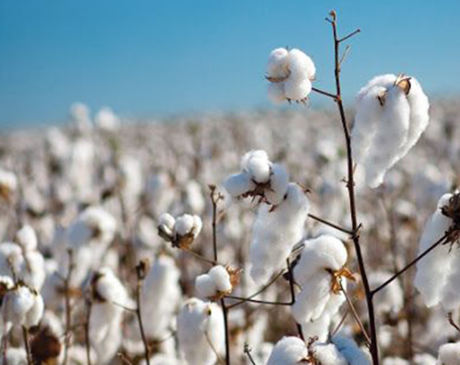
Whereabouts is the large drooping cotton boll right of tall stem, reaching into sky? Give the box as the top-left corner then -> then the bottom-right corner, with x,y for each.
351,74 -> 429,188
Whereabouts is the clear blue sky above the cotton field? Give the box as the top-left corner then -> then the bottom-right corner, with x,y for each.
0,0 -> 460,126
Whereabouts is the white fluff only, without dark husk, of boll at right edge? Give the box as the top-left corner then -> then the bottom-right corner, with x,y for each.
414,194 -> 456,307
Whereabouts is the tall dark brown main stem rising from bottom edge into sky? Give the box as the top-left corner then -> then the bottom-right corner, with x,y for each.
327,11 -> 379,365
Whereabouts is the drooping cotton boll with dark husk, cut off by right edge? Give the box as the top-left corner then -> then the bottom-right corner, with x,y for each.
414,193 -> 460,312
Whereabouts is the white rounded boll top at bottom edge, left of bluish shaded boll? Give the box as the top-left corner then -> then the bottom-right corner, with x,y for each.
267,337 -> 308,365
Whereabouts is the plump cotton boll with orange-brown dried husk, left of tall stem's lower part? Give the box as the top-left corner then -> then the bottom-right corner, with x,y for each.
292,235 -> 353,337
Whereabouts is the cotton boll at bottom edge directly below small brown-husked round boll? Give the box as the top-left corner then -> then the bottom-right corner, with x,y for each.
177,298 -> 224,365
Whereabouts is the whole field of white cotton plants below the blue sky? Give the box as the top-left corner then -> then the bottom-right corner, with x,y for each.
0,8 -> 460,365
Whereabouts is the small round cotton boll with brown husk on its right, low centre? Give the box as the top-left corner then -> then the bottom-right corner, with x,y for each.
195,265 -> 240,301
